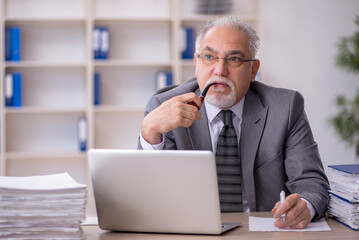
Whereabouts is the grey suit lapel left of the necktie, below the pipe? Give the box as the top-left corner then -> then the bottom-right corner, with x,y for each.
187,88 -> 212,151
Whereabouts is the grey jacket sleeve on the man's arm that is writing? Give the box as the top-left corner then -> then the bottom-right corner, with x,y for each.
284,92 -> 329,221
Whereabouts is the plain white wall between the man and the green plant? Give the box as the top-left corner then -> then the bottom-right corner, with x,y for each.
260,0 -> 359,171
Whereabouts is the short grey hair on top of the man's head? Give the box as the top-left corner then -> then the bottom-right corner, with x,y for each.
196,16 -> 259,58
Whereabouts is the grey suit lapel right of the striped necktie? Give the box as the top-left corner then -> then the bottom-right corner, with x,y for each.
240,89 -> 268,211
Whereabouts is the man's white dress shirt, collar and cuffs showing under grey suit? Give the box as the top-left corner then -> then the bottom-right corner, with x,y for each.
140,98 -> 315,218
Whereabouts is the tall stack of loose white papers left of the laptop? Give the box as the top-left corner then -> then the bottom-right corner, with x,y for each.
0,173 -> 87,239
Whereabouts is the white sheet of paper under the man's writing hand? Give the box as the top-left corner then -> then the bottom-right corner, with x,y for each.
249,217 -> 331,232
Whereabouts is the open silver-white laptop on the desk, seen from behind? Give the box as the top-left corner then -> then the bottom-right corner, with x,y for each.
89,149 -> 239,234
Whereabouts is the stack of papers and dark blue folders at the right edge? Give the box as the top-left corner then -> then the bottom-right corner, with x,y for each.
328,164 -> 359,230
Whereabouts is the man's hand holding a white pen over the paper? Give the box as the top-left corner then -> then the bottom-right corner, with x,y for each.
272,193 -> 312,228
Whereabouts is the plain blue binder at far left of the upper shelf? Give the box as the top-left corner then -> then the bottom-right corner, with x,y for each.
5,27 -> 21,62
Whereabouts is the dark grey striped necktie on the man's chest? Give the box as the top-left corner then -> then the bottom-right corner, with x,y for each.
216,110 -> 243,212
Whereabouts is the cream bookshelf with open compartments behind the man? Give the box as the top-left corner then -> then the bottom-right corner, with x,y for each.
0,0 -> 260,216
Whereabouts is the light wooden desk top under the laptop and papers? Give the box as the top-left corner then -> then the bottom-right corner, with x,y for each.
83,212 -> 359,240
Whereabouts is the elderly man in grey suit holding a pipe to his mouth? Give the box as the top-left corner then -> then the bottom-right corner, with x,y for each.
139,17 -> 329,228
